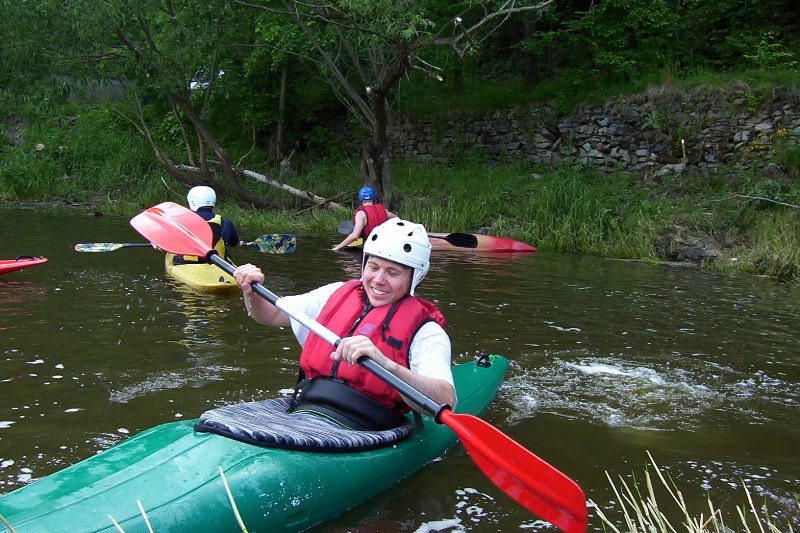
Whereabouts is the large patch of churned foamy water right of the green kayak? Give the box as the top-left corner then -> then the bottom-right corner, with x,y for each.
501,350 -> 800,431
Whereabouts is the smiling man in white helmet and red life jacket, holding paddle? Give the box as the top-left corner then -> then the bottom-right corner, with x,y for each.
234,218 -> 456,430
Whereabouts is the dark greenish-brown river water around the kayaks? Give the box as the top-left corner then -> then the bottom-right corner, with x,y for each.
0,207 -> 800,532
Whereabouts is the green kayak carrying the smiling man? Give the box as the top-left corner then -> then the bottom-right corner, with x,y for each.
0,356 -> 508,533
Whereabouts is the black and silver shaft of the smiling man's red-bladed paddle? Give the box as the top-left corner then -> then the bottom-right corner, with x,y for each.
206,250 -> 450,418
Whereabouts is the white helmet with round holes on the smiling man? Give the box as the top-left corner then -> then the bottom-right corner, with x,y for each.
361,218 -> 431,296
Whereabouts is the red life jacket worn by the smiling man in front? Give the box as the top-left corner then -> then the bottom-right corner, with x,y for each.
300,280 -> 445,413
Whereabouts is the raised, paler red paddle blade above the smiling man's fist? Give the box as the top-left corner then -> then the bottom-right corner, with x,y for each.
131,202 -> 214,257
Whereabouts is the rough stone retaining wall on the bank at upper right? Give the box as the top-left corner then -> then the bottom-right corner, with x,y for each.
393,84 -> 800,176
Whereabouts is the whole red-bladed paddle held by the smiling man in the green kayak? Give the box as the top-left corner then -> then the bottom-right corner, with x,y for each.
126,202 -> 588,533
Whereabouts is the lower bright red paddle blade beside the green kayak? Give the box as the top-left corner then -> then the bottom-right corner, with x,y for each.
440,410 -> 588,533
